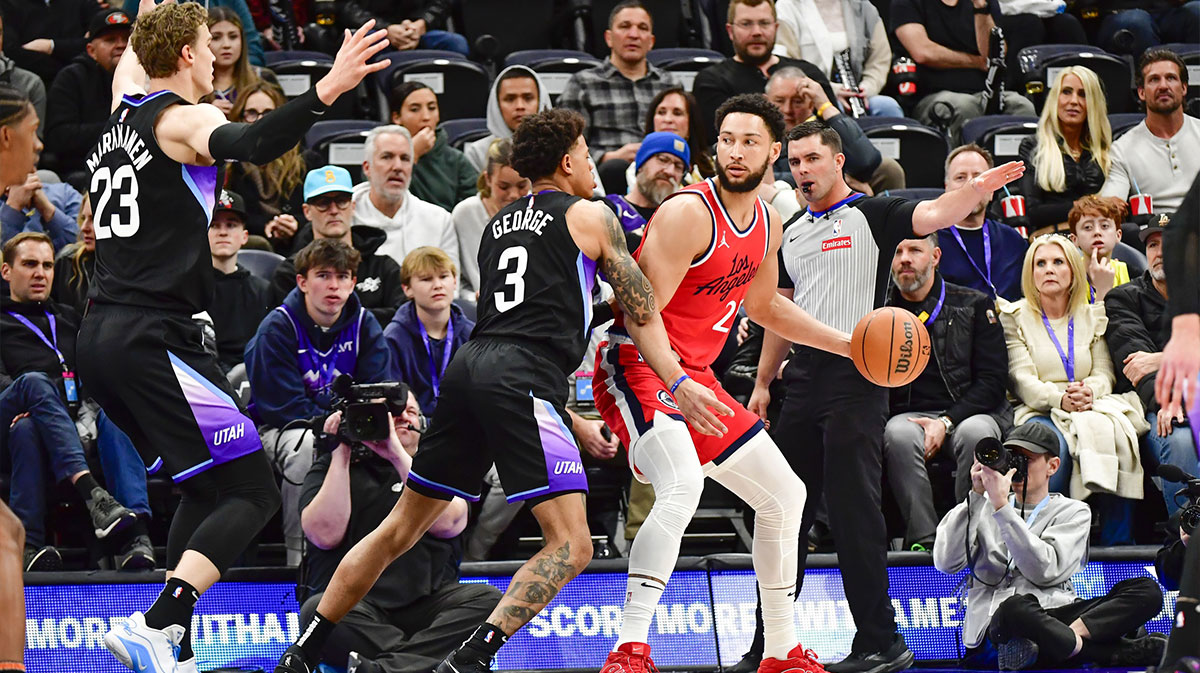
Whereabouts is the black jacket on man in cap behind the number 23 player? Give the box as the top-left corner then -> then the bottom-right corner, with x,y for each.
46,54 -> 113,173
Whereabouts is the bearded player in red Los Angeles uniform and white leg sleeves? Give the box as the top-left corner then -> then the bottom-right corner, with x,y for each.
594,95 -> 850,673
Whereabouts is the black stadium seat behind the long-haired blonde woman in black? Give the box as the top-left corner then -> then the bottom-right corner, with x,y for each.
1018,44 -> 1134,113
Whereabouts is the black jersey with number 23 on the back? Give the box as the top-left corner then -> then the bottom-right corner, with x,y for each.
88,90 -> 225,313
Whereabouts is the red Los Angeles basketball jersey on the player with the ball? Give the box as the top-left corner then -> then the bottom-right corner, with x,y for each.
617,178 -> 770,368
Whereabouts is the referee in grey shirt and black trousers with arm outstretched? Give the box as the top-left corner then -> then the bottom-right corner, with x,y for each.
749,121 -> 1025,673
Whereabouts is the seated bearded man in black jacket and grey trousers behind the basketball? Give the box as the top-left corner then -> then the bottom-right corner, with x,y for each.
883,234 -> 1013,551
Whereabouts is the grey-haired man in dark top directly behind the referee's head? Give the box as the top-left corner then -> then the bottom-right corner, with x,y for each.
766,66 -> 905,194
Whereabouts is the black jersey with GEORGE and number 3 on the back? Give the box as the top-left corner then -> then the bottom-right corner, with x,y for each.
472,191 -> 596,375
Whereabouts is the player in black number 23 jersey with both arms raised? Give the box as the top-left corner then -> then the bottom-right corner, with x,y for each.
78,0 -> 386,673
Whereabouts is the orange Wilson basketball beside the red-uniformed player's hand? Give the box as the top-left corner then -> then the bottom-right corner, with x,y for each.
850,306 -> 930,387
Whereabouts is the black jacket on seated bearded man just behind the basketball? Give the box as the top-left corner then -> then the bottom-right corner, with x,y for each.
888,272 -> 1013,429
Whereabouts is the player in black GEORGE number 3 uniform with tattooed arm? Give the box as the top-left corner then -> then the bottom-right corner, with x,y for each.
275,109 -> 720,673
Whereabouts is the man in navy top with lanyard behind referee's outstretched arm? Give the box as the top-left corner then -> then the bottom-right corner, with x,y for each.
937,143 -> 1028,301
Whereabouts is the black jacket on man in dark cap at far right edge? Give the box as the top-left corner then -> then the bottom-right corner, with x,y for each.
1104,271 -> 1171,411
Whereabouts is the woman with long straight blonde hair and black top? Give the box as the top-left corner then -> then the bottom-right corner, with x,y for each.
1019,66 -> 1112,233
